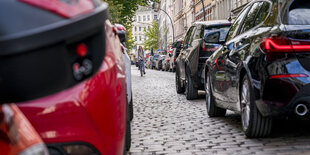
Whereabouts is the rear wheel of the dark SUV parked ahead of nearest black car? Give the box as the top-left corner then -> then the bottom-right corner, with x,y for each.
185,69 -> 198,100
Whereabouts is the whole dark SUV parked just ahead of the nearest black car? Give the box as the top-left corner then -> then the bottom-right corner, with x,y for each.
176,20 -> 231,100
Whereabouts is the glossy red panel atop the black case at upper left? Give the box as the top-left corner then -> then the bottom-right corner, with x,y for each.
19,0 -> 95,18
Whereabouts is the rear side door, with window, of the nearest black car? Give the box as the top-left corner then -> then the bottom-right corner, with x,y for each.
224,1 -> 269,110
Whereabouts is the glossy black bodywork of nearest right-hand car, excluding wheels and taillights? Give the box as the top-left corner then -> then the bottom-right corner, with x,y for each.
205,0 -> 310,116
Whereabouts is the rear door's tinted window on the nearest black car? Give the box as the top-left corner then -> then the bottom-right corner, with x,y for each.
241,2 -> 263,33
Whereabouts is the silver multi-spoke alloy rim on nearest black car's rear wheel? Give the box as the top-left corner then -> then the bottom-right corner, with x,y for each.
241,80 -> 251,131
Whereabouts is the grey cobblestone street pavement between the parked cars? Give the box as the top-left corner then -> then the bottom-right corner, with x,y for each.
129,66 -> 310,155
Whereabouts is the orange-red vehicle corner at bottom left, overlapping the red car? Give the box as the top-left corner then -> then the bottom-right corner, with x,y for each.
0,104 -> 48,155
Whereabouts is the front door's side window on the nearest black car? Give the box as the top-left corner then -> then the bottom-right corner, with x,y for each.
226,6 -> 250,41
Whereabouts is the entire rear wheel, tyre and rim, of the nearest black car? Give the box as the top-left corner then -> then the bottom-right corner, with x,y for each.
240,75 -> 272,138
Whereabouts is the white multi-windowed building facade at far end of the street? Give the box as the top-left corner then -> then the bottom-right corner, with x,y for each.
132,6 -> 158,49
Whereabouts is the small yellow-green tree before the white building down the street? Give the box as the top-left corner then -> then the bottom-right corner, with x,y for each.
144,19 -> 159,50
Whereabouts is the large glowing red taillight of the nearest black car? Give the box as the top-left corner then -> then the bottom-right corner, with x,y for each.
261,38 -> 310,53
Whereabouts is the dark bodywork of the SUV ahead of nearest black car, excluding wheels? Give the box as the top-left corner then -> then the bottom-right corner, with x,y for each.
176,21 -> 230,90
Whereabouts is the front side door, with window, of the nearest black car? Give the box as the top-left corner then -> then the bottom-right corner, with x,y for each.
211,3 -> 250,109
